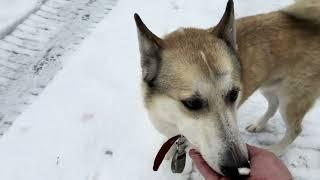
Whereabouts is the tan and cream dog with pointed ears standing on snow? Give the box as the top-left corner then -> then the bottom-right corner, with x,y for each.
135,0 -> 320,175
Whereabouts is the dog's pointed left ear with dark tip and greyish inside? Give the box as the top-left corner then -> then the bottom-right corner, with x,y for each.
134,14 -> 163,85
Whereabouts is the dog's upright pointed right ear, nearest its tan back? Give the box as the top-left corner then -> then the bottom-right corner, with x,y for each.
213,0 -> 237,50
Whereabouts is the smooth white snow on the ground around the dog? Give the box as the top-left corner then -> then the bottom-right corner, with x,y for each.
0,0 -> 320,180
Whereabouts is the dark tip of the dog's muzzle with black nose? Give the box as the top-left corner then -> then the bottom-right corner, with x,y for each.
220,150 -> 250,178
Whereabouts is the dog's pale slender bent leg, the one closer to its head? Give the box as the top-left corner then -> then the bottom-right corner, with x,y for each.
246,89 -> 279,132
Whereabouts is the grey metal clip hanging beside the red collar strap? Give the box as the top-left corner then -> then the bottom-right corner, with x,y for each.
171,136 -> 187,173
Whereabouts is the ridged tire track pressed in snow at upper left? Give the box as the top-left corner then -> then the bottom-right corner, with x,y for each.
0,0 -> 117,136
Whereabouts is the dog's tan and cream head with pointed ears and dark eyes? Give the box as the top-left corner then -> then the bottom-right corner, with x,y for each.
135,1 -> 248,175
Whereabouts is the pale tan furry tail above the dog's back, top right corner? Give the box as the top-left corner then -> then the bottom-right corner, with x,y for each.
282,0 -> 320,24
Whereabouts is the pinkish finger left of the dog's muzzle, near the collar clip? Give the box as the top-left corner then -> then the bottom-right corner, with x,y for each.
189,149 -> 221,180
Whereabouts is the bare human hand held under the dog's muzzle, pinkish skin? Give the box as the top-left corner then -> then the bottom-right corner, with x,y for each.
189,145 -> 293,180
